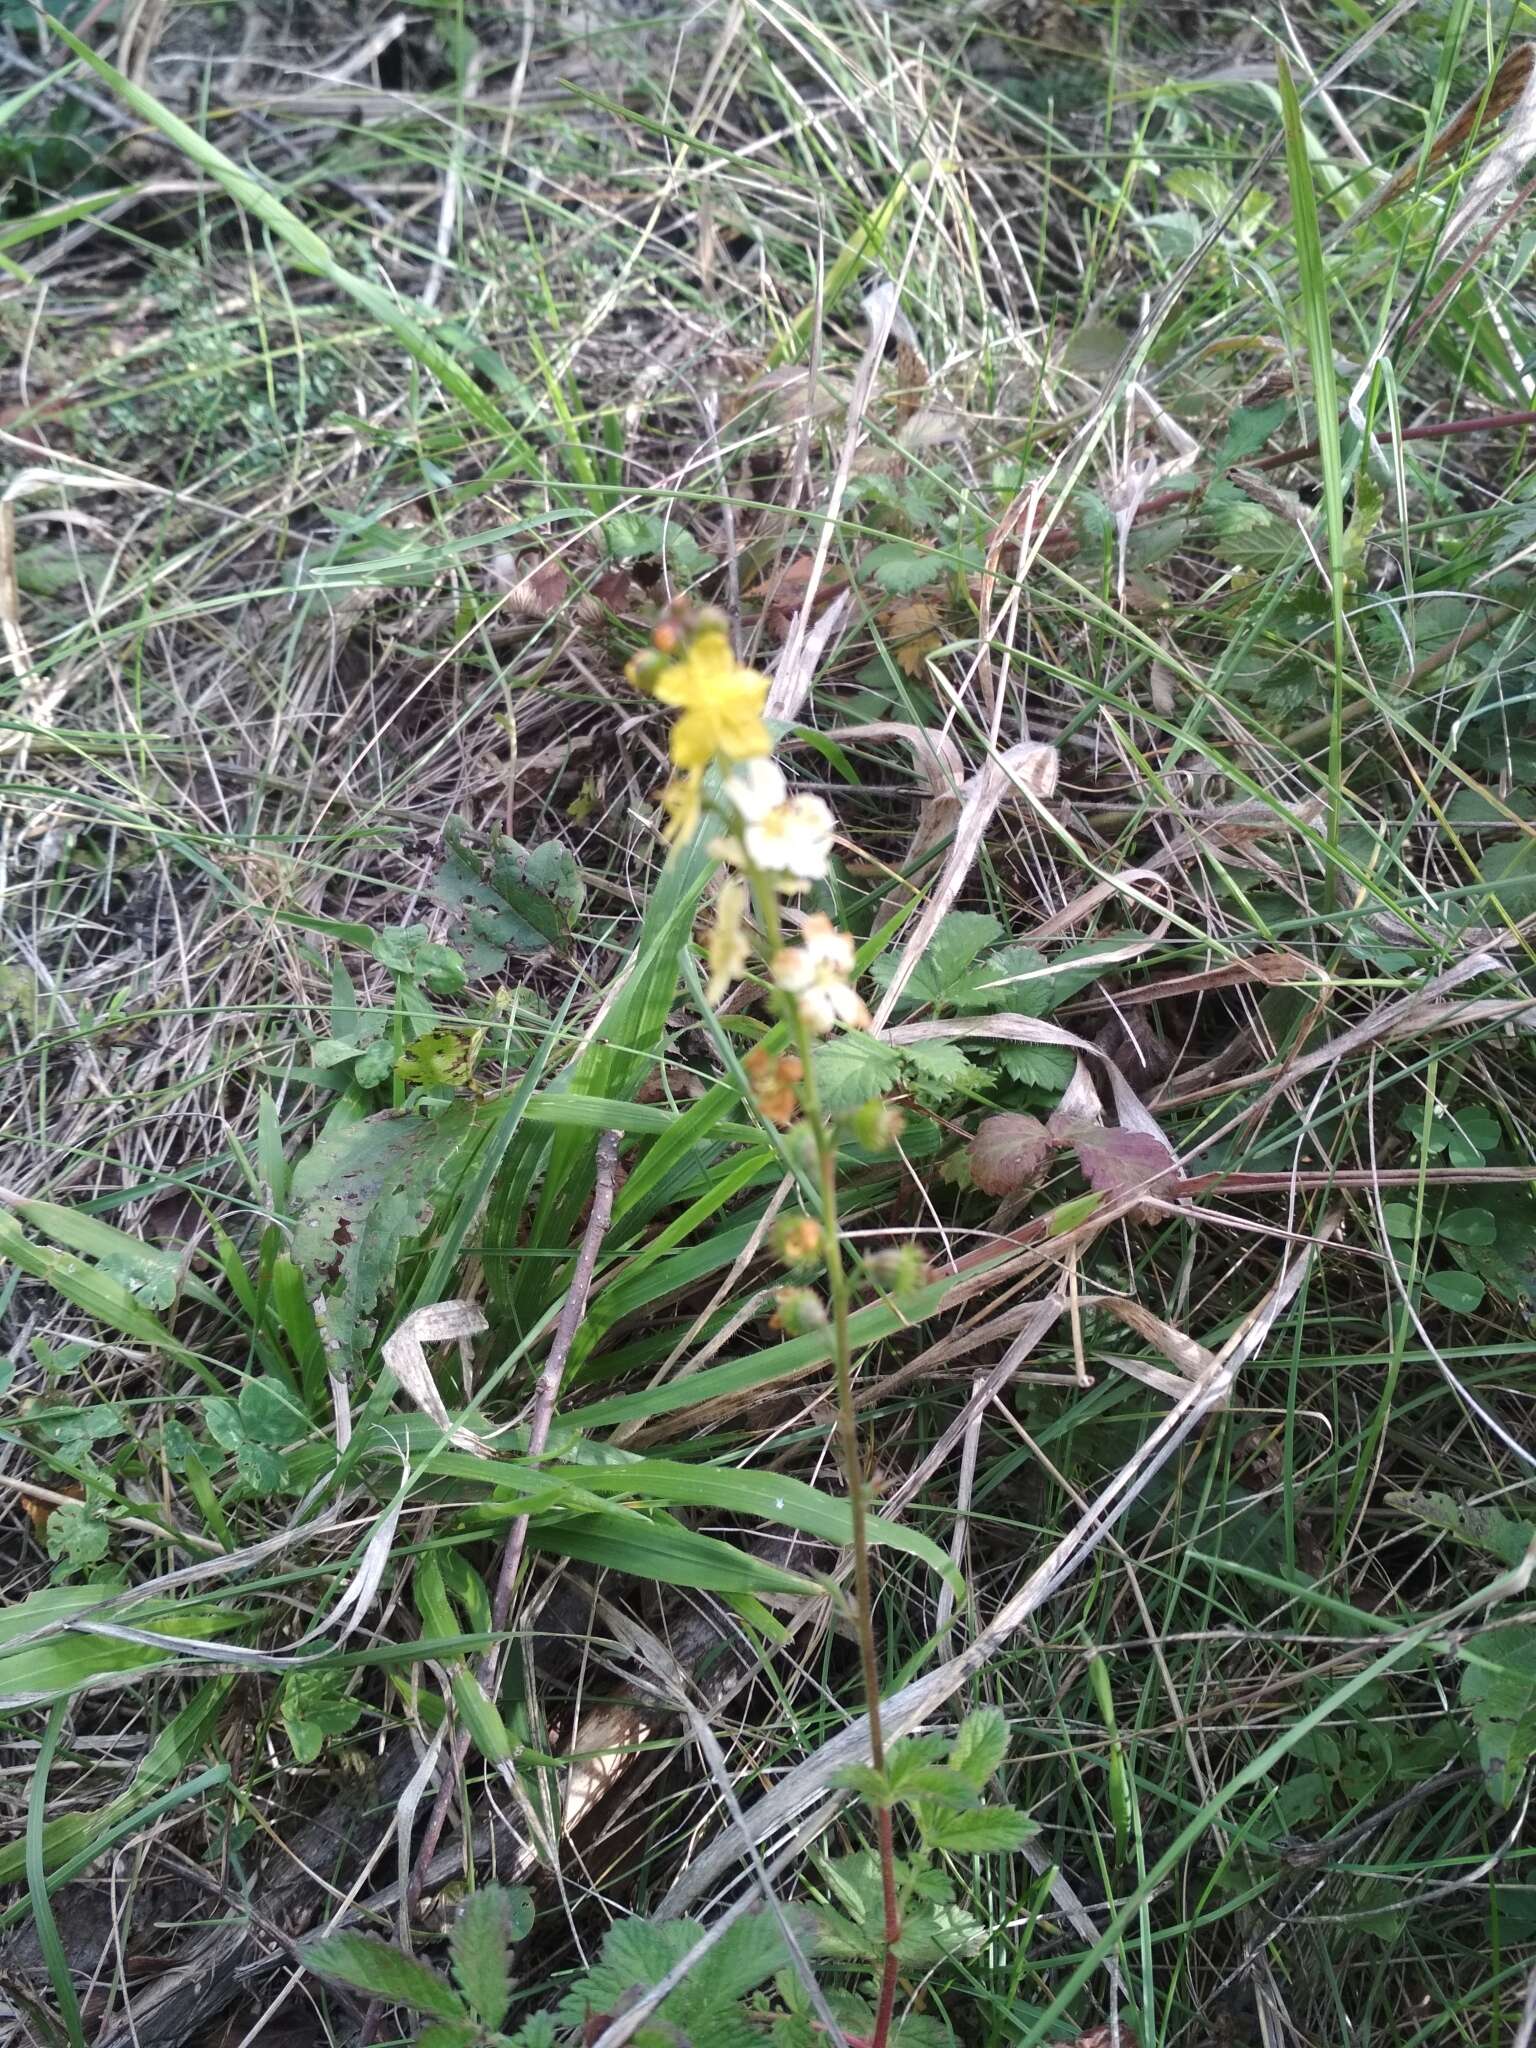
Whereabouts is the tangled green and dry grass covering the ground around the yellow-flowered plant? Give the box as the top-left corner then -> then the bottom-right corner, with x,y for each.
0,0 -> 1536,2048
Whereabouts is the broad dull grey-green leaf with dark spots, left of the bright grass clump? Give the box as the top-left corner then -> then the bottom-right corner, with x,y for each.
293,1102 -> 492,1370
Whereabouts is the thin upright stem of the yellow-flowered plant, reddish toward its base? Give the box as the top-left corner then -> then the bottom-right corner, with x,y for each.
748,866 -> 901,2048
